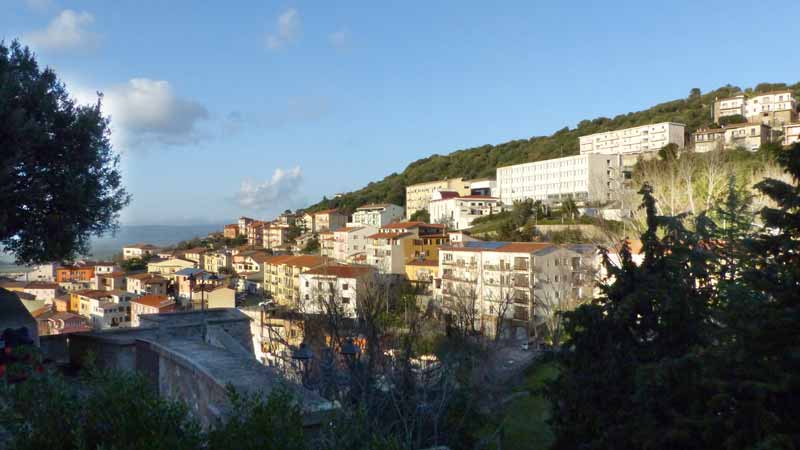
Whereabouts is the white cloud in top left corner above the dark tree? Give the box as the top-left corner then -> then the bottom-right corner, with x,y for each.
22,9 -> 99,50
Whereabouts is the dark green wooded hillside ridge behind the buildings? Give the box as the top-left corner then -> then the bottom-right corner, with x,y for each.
307,82 -> 800,211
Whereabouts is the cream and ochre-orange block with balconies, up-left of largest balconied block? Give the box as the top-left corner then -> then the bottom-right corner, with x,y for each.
366,222 -> 448,275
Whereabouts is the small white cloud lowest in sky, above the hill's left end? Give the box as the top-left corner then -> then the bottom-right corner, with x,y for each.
236,167 -> 303,211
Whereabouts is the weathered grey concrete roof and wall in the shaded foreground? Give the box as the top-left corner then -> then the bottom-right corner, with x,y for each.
43,309 -> 333,428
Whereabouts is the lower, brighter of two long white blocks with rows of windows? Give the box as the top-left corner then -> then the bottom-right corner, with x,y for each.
497,154 -> 623,205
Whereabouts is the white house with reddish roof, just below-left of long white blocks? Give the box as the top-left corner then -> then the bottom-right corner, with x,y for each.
429,191 -> 503,230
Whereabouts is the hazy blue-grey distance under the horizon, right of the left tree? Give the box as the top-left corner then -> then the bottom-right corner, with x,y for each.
0,224 -> 223,271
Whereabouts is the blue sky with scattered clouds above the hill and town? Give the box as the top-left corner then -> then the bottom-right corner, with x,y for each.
0,0 -> 800,224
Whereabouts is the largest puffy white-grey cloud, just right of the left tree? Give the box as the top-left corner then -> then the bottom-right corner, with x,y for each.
68,78 -> 209,150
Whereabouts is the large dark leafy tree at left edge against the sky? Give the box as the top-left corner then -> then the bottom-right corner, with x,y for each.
0,41 -> 130,263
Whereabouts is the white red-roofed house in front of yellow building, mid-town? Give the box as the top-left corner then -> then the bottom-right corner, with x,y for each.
299,265 -> 375,319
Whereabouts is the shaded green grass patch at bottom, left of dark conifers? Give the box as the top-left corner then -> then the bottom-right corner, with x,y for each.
484,362 -> 558,450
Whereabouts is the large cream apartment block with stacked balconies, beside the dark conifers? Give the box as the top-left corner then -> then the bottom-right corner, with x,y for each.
439,242 -> 594,336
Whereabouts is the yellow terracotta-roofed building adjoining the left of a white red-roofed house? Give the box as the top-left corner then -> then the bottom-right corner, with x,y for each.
263,255 -> 330,308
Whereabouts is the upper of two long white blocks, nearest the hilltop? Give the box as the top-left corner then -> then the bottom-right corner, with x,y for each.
580,122 -> 686,157
